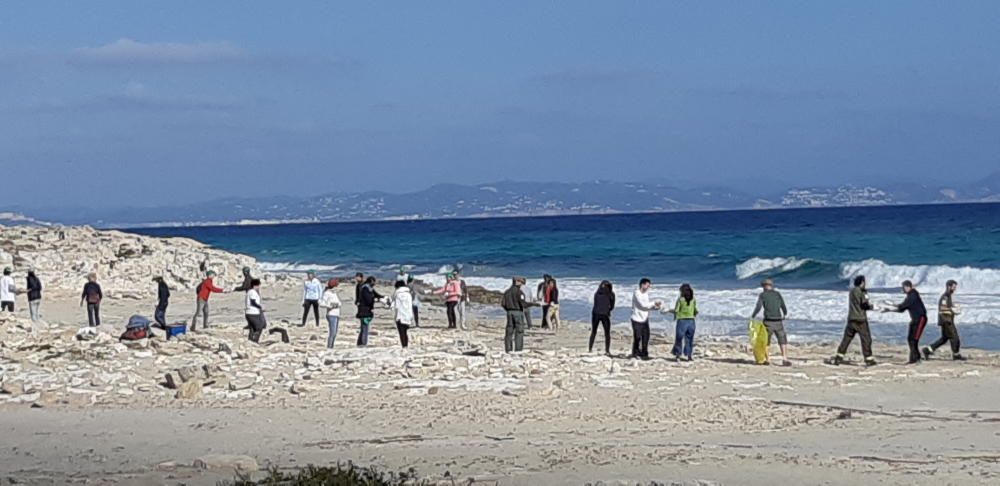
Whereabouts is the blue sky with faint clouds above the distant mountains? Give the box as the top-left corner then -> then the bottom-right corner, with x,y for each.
0,0 -> 1000,209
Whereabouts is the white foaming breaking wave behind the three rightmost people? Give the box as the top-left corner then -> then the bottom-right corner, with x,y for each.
840,259 -> 1000,294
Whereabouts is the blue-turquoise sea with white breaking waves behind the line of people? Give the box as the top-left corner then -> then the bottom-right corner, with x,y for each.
133,204 -> 1000,347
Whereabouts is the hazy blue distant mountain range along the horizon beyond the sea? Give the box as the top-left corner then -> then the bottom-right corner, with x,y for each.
7,172 -> 1000,227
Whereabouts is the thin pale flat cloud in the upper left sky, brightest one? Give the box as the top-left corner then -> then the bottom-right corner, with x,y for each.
70,39 -> 250,66
